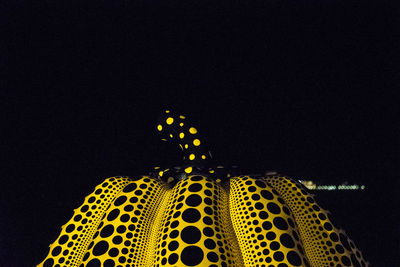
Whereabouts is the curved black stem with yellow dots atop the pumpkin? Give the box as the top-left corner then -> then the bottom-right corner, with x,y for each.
157,110 -> 211,173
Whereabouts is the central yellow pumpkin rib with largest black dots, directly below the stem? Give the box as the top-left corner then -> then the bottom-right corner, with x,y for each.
154,176 -> 242,267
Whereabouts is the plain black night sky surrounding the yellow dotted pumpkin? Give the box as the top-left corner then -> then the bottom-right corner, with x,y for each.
0,0 -> 400,266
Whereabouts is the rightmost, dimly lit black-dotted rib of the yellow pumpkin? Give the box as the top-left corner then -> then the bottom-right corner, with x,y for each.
265,176 -> 369,267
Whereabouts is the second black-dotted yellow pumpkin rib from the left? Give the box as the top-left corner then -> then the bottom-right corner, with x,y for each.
81,177 -> 167,266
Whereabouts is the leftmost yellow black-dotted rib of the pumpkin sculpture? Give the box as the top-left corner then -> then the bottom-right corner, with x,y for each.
39,177 -> 130,267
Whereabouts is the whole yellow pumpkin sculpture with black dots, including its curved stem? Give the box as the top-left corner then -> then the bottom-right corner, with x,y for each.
39,111 -> 369,267
